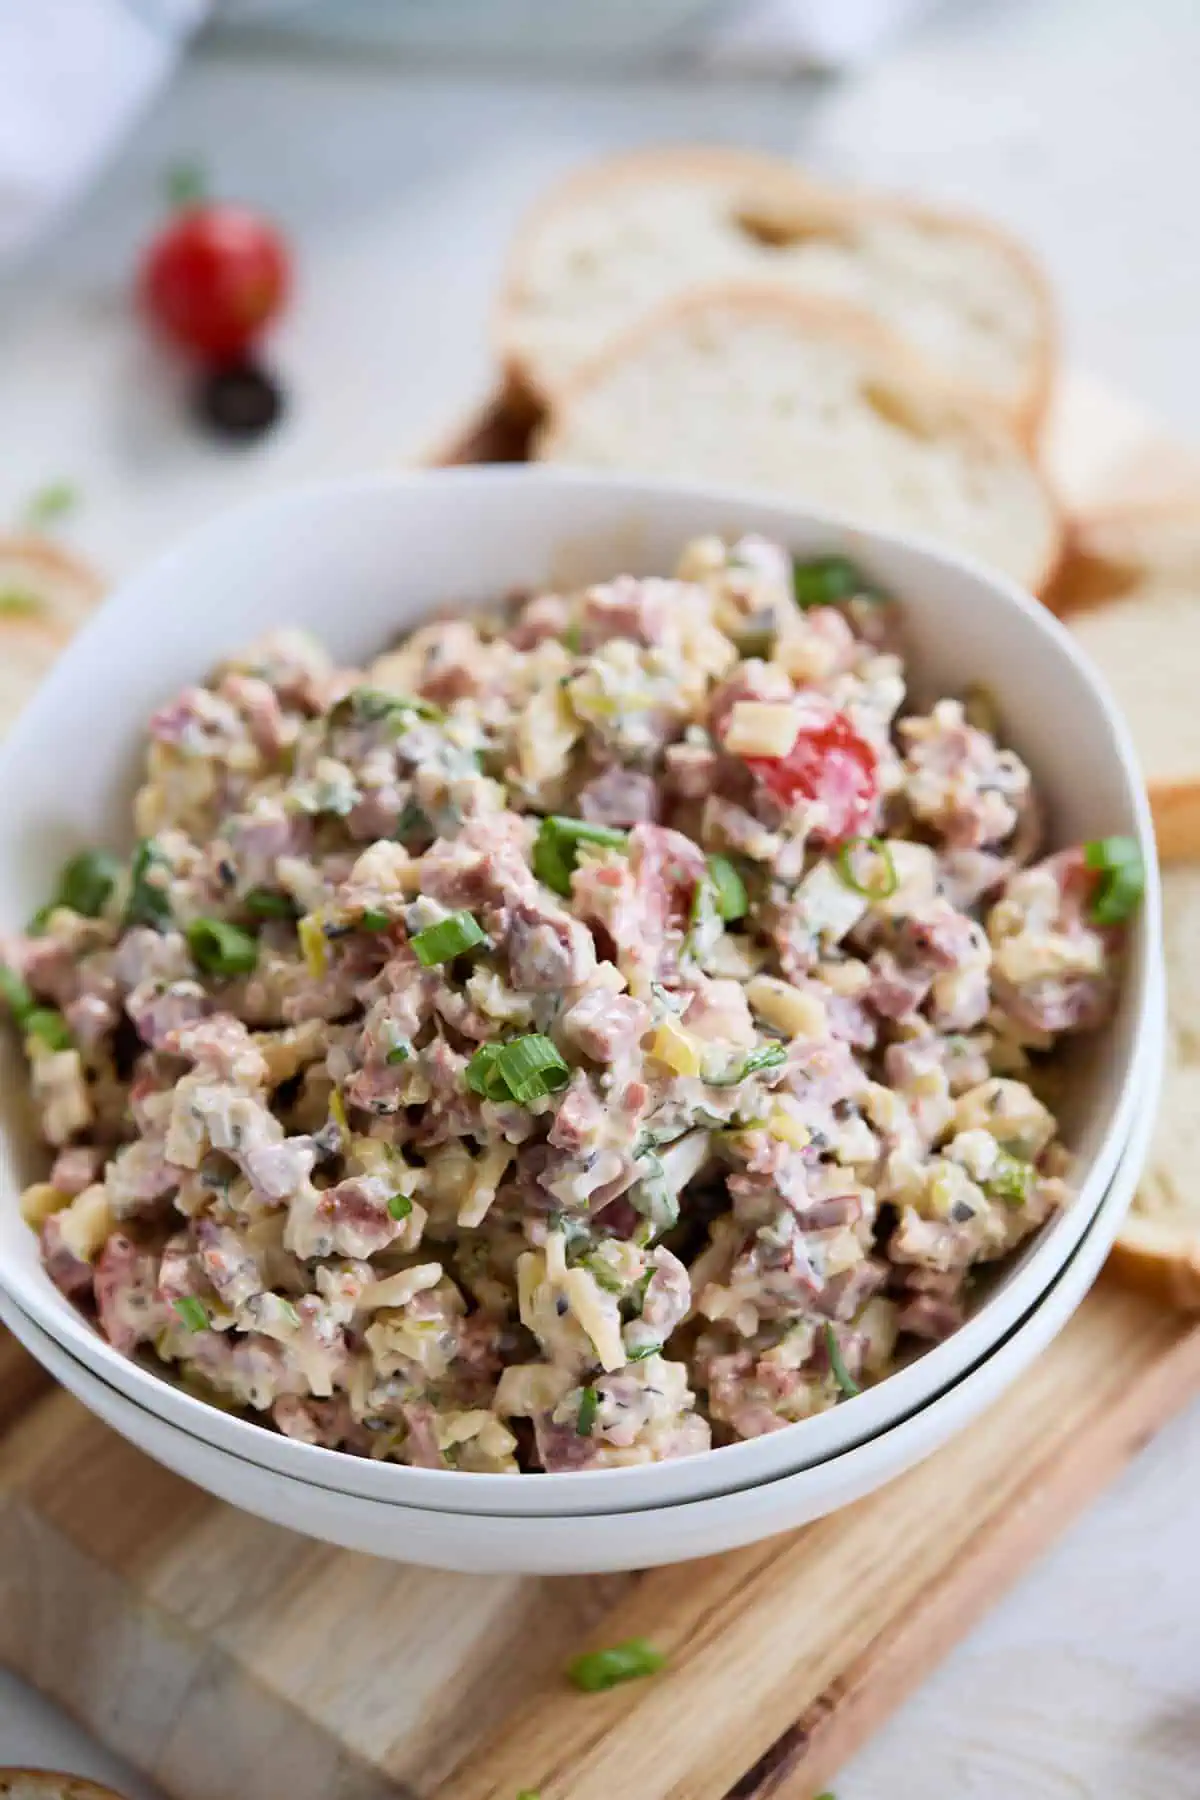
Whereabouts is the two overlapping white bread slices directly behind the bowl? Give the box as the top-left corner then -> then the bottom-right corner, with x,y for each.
498,149 -> 1061,590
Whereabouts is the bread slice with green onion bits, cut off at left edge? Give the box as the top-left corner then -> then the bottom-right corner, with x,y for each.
0,536 -> 104,731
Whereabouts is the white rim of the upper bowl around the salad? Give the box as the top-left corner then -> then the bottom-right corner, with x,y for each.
0,464 -> 1160,1516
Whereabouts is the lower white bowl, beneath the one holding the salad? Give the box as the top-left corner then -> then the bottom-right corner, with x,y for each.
0,985 -> 1166,1575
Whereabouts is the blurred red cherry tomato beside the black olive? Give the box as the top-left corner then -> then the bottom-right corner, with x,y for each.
139,205 -> 291,364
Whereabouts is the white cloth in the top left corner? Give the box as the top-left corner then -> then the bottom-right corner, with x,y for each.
0,0 -> 209,257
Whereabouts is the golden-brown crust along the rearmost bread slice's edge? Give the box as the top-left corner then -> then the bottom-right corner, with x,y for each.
493,144 -> 1058,443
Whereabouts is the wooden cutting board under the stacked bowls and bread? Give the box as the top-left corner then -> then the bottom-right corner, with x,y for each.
0,369 -> 1200,1800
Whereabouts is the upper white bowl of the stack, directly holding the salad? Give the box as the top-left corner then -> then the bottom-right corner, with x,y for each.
0,468 -> 1160,1516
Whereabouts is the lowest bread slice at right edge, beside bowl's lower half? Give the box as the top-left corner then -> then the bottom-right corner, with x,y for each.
1112,868 -> 1200,1309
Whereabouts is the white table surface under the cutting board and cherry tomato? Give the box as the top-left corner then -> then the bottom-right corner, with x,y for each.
0,0 -> 1200,1800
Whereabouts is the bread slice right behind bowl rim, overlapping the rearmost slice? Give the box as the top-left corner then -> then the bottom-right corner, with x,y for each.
534,288 -> 1061,590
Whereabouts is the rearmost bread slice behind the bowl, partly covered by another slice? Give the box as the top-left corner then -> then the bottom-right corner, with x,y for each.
497,148 -> 1056,436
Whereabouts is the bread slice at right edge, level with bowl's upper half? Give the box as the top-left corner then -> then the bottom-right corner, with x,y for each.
1051,493 -> 1200,860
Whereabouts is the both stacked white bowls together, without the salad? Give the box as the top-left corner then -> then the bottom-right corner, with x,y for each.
0,468 -> 1164,1573
